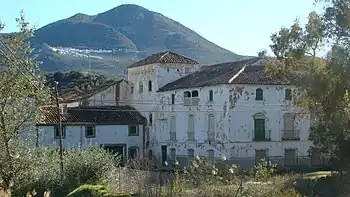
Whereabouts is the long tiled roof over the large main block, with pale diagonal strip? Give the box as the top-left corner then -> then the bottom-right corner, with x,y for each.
158,58 -> 283,92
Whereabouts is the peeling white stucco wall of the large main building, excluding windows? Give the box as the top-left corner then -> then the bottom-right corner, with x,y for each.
151,85 -> 312,166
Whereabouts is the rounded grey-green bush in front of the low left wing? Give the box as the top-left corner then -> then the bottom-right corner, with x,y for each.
13,148 -> 118,196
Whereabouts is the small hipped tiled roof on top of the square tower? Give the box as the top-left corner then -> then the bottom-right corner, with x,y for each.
128,51 -> 199,68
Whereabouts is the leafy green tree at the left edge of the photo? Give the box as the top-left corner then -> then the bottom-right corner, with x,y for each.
0,13 -> 48,193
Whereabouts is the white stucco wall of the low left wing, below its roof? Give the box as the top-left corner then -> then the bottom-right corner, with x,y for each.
38,125 -> 143,159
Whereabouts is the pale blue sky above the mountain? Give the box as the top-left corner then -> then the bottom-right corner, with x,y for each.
0,0 -> 322,56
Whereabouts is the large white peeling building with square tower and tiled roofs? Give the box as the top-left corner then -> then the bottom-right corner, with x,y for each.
128,52 -> 318,169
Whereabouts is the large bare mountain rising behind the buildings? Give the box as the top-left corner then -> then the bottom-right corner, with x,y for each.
31,4 -> 249,75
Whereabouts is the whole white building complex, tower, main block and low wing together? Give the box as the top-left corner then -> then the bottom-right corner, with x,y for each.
36,51 -> 327,168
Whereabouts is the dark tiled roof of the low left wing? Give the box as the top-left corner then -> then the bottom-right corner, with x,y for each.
37,106 -> 146,125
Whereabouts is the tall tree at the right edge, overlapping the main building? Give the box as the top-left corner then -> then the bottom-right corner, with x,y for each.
266,0 -> 350,169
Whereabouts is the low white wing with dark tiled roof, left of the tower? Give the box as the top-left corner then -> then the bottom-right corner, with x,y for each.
37,106 -> 147,164
